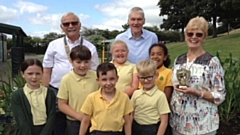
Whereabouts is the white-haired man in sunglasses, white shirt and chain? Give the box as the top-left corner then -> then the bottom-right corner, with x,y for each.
42,12 -> 99,135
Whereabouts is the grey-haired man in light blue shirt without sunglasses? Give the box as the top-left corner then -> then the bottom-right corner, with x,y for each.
116,7 -> 158,64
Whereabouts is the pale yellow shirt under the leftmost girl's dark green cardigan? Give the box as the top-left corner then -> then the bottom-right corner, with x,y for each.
23,84 -> 48,126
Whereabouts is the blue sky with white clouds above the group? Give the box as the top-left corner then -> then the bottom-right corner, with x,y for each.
0,0 -> 162,37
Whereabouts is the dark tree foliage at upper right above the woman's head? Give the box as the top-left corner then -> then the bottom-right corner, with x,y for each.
158,0 -> 240,40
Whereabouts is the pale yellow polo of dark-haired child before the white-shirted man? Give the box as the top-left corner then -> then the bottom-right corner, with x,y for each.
57,70 -> 99,120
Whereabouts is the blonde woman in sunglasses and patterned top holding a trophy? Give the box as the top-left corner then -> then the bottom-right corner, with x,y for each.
170,17 -> 226,135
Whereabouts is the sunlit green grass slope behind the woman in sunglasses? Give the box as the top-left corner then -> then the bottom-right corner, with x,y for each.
167,31 -> 240,63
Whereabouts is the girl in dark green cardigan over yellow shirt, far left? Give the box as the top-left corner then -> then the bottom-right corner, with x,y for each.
11,59 -> 56,135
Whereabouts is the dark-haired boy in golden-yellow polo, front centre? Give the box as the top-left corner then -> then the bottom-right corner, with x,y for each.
79,63 -> 133,135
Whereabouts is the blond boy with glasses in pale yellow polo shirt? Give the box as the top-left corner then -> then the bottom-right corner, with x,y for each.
131,60 -> 170,135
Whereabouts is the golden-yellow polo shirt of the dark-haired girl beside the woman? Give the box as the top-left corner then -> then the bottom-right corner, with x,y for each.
139,66 -> 173,92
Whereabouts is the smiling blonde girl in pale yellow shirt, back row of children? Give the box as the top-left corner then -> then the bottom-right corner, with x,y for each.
111,40 -> 138,97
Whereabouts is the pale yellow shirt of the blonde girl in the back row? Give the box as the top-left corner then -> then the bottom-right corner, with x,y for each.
111,61 -> 137,91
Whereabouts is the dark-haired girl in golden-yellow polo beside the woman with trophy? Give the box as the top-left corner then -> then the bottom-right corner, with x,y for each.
149,44 -> 173,102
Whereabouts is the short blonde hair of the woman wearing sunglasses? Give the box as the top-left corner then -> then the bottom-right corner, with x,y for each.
185,16 -> 209,38
